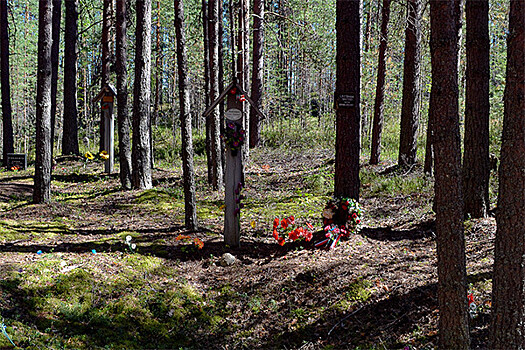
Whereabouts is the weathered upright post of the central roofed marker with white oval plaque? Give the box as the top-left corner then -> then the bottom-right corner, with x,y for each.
224,87 -> 245,247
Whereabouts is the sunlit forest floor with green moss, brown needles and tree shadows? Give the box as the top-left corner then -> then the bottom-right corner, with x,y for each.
0,150 -> 495,349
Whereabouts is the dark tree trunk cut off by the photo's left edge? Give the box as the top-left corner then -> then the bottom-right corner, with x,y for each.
0,1 -> 14,166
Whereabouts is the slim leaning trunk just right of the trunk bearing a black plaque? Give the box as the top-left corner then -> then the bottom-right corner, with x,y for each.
370,0 -> 390,165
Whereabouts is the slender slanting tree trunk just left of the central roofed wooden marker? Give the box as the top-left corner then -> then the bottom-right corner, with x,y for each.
175,0 -> 198,230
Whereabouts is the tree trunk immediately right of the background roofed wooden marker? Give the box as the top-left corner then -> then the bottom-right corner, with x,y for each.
116,0 -> 131,190
